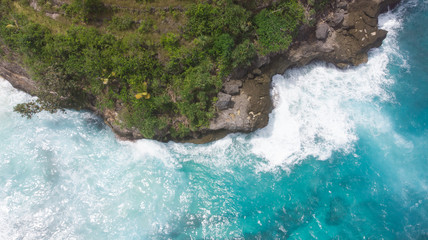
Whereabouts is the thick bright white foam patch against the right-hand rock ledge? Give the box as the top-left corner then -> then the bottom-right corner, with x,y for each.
251,8 -> 405,171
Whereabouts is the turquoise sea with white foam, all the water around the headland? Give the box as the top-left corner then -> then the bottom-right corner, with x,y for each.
0,0 -> 428,239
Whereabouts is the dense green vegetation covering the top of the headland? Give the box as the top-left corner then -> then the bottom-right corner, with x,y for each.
0,0 -> 332,138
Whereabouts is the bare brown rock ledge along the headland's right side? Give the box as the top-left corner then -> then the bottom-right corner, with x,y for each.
205,0 -> 399,141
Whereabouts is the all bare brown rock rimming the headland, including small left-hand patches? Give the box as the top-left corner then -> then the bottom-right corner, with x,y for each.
0,0 -> 399,143
